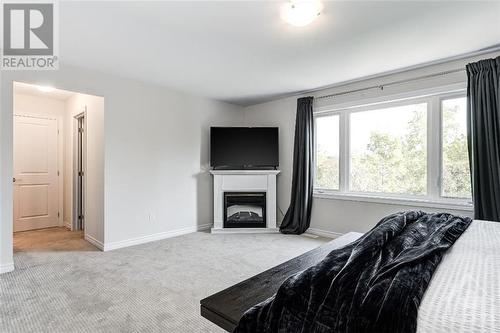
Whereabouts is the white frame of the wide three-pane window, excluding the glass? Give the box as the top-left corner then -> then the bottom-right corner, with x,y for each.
313,85 -> 473,211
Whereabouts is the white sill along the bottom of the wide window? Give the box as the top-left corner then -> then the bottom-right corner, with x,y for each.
313,190 -> 474,212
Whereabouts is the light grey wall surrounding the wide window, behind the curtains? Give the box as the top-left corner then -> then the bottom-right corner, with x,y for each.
244,52 -> 499,236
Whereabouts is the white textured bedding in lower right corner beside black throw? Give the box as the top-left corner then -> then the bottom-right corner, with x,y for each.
417,220 -> 500,333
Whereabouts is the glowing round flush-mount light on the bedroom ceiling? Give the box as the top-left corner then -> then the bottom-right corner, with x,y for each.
281,0 -> 323,27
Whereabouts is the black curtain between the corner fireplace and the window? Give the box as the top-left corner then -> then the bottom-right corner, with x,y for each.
280,97 -> 314,235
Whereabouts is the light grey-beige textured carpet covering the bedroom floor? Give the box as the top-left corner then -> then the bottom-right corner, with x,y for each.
0,232 -> 326,333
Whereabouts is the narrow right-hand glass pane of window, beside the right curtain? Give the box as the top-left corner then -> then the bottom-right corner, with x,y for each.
441,97 -> 471,198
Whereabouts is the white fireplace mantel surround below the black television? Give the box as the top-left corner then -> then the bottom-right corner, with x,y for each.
210,170 -> 280,233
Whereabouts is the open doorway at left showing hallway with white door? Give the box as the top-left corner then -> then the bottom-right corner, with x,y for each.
13,82 -> 104,252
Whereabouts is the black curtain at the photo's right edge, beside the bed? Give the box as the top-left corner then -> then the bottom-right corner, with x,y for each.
467,57 -> 500,221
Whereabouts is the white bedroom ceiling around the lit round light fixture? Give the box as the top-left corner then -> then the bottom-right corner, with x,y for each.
60,1 -> 500,105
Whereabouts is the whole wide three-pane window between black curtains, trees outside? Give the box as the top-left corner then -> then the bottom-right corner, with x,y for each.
314,89 -> 471,207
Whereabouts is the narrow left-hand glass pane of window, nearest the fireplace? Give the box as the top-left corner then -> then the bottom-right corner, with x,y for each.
315,115 -> 339,190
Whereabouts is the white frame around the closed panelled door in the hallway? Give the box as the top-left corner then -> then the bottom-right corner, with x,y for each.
12,111 -> 64,227
